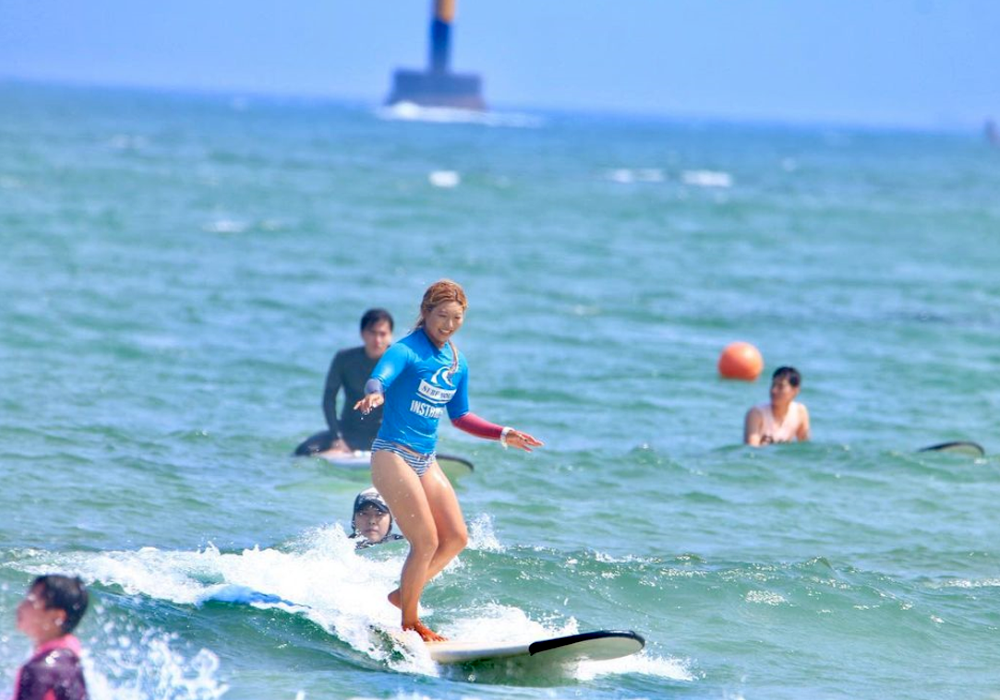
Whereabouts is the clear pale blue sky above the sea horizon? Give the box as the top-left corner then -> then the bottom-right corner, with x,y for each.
0,0 -> 1000,128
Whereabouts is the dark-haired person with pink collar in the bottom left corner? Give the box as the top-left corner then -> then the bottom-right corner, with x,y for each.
13,574 -> 88,700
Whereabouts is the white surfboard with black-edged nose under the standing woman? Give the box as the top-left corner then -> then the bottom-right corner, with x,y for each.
427,630 -> 646,664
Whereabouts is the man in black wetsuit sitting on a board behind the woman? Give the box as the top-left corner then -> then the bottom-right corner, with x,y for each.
295,309 -> 394,455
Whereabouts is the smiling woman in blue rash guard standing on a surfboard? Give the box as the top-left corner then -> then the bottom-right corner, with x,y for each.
355,279 -> 542,642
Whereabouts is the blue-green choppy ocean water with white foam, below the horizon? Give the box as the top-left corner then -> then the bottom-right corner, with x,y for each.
0,82 -> 1000,700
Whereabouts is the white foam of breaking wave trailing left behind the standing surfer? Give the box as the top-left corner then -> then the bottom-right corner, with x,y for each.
11,528 -> 523,675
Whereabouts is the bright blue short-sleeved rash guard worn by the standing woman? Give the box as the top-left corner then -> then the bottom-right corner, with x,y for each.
371,328 -> 469,455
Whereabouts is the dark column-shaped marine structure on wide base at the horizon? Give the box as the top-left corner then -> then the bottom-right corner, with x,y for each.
386,0 -> 486,110
